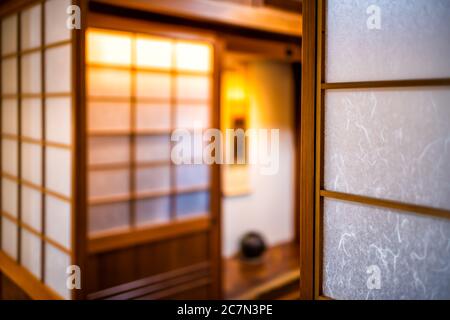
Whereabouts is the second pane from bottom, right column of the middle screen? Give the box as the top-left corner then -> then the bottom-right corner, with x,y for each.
176,164 -> 210,189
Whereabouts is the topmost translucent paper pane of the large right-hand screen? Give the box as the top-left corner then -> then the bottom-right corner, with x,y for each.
325,0 -> 450,82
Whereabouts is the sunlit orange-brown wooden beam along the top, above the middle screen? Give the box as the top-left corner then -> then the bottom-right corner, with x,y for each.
91,0 -> 302,37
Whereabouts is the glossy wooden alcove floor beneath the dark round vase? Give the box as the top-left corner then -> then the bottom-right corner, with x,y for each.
223,242 -> 300,299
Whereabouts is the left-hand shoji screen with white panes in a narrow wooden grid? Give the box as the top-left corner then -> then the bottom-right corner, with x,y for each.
0,0 -> 73,298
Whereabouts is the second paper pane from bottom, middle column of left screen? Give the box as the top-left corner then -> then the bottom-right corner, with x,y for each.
21,186 -> 42,231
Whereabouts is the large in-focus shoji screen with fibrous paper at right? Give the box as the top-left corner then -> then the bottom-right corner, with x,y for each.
316,0 -> 450,299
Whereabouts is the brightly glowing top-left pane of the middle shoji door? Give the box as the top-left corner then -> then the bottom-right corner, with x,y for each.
87,29 -> 132,66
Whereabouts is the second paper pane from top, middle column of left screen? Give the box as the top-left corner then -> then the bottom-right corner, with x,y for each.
20,52 -> 42,94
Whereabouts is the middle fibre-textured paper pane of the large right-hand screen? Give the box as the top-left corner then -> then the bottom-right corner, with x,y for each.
324,87 -> 450,209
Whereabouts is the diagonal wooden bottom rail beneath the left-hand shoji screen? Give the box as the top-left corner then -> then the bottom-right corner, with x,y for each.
0,251 -> 62,300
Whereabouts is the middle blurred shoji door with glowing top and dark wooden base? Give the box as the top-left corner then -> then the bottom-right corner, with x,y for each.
86,13 -> 220,299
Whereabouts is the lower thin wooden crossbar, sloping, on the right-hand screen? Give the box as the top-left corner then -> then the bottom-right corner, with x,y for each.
320,190 -> 450,219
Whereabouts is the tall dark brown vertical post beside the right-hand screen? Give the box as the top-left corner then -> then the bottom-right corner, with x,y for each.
299,0 -> 318,300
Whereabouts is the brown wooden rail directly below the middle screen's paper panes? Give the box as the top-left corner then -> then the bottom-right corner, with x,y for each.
88,217 -> 211,254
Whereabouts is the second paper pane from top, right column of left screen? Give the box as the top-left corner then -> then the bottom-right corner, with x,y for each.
45,44 -> 72,93
